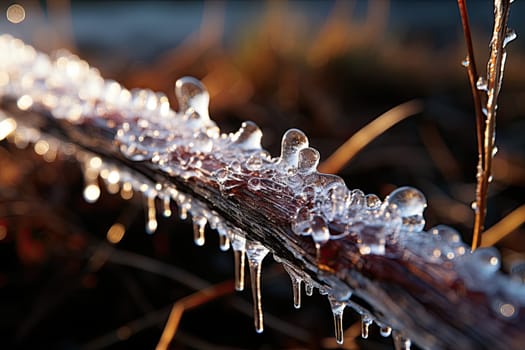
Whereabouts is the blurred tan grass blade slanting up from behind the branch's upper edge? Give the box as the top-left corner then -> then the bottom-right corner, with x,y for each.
319,100 -> 423,174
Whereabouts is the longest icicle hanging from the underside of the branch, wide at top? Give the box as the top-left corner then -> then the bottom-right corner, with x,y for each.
246,241 -> 269,333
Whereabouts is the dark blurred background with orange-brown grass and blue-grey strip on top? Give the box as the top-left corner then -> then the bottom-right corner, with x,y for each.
0,0 -> 525,349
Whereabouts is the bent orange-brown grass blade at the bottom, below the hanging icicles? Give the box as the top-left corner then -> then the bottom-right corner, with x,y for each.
156,281 -> 235,350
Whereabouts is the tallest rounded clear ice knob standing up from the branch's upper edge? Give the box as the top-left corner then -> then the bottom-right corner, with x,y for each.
175,77 -> 210,119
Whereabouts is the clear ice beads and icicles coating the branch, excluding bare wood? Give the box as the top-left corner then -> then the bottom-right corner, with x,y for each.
0,35 -> 525,349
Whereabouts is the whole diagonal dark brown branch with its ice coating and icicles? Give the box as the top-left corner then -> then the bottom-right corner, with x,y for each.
0,36 -> 525,349
